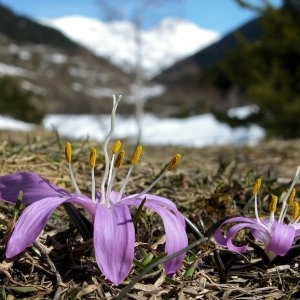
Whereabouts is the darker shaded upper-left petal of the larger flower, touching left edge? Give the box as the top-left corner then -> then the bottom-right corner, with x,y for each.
0,172 -> 68,205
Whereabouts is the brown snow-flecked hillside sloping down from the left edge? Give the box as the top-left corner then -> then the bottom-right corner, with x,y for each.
0,5 -> 130,118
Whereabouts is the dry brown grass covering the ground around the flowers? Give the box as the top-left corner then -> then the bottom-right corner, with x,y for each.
0,131 -> 300,299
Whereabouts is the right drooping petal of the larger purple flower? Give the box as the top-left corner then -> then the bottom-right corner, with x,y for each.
122,194 -> 188,275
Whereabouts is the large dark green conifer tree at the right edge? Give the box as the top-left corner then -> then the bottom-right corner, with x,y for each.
214,0 -> 300,138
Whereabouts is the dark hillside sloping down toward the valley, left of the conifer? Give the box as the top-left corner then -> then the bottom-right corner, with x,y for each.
148,19 -> 262,117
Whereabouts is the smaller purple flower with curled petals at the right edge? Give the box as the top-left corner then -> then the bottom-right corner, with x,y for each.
214,167 -> 300,261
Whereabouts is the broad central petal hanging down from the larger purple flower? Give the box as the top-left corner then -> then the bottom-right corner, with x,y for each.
94,204 -> 135,285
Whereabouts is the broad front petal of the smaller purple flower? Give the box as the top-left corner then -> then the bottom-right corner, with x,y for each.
267,221 -> 296,256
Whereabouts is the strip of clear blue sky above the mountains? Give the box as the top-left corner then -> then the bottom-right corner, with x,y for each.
0,0 -> 282,35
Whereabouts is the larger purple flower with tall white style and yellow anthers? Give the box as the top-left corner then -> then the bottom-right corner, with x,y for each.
0,98 -> 188,285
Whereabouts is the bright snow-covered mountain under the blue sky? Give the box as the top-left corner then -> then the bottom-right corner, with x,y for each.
41,15 -> 219,77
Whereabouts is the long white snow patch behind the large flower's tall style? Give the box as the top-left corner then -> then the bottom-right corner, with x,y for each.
43,114 -> 265,147
